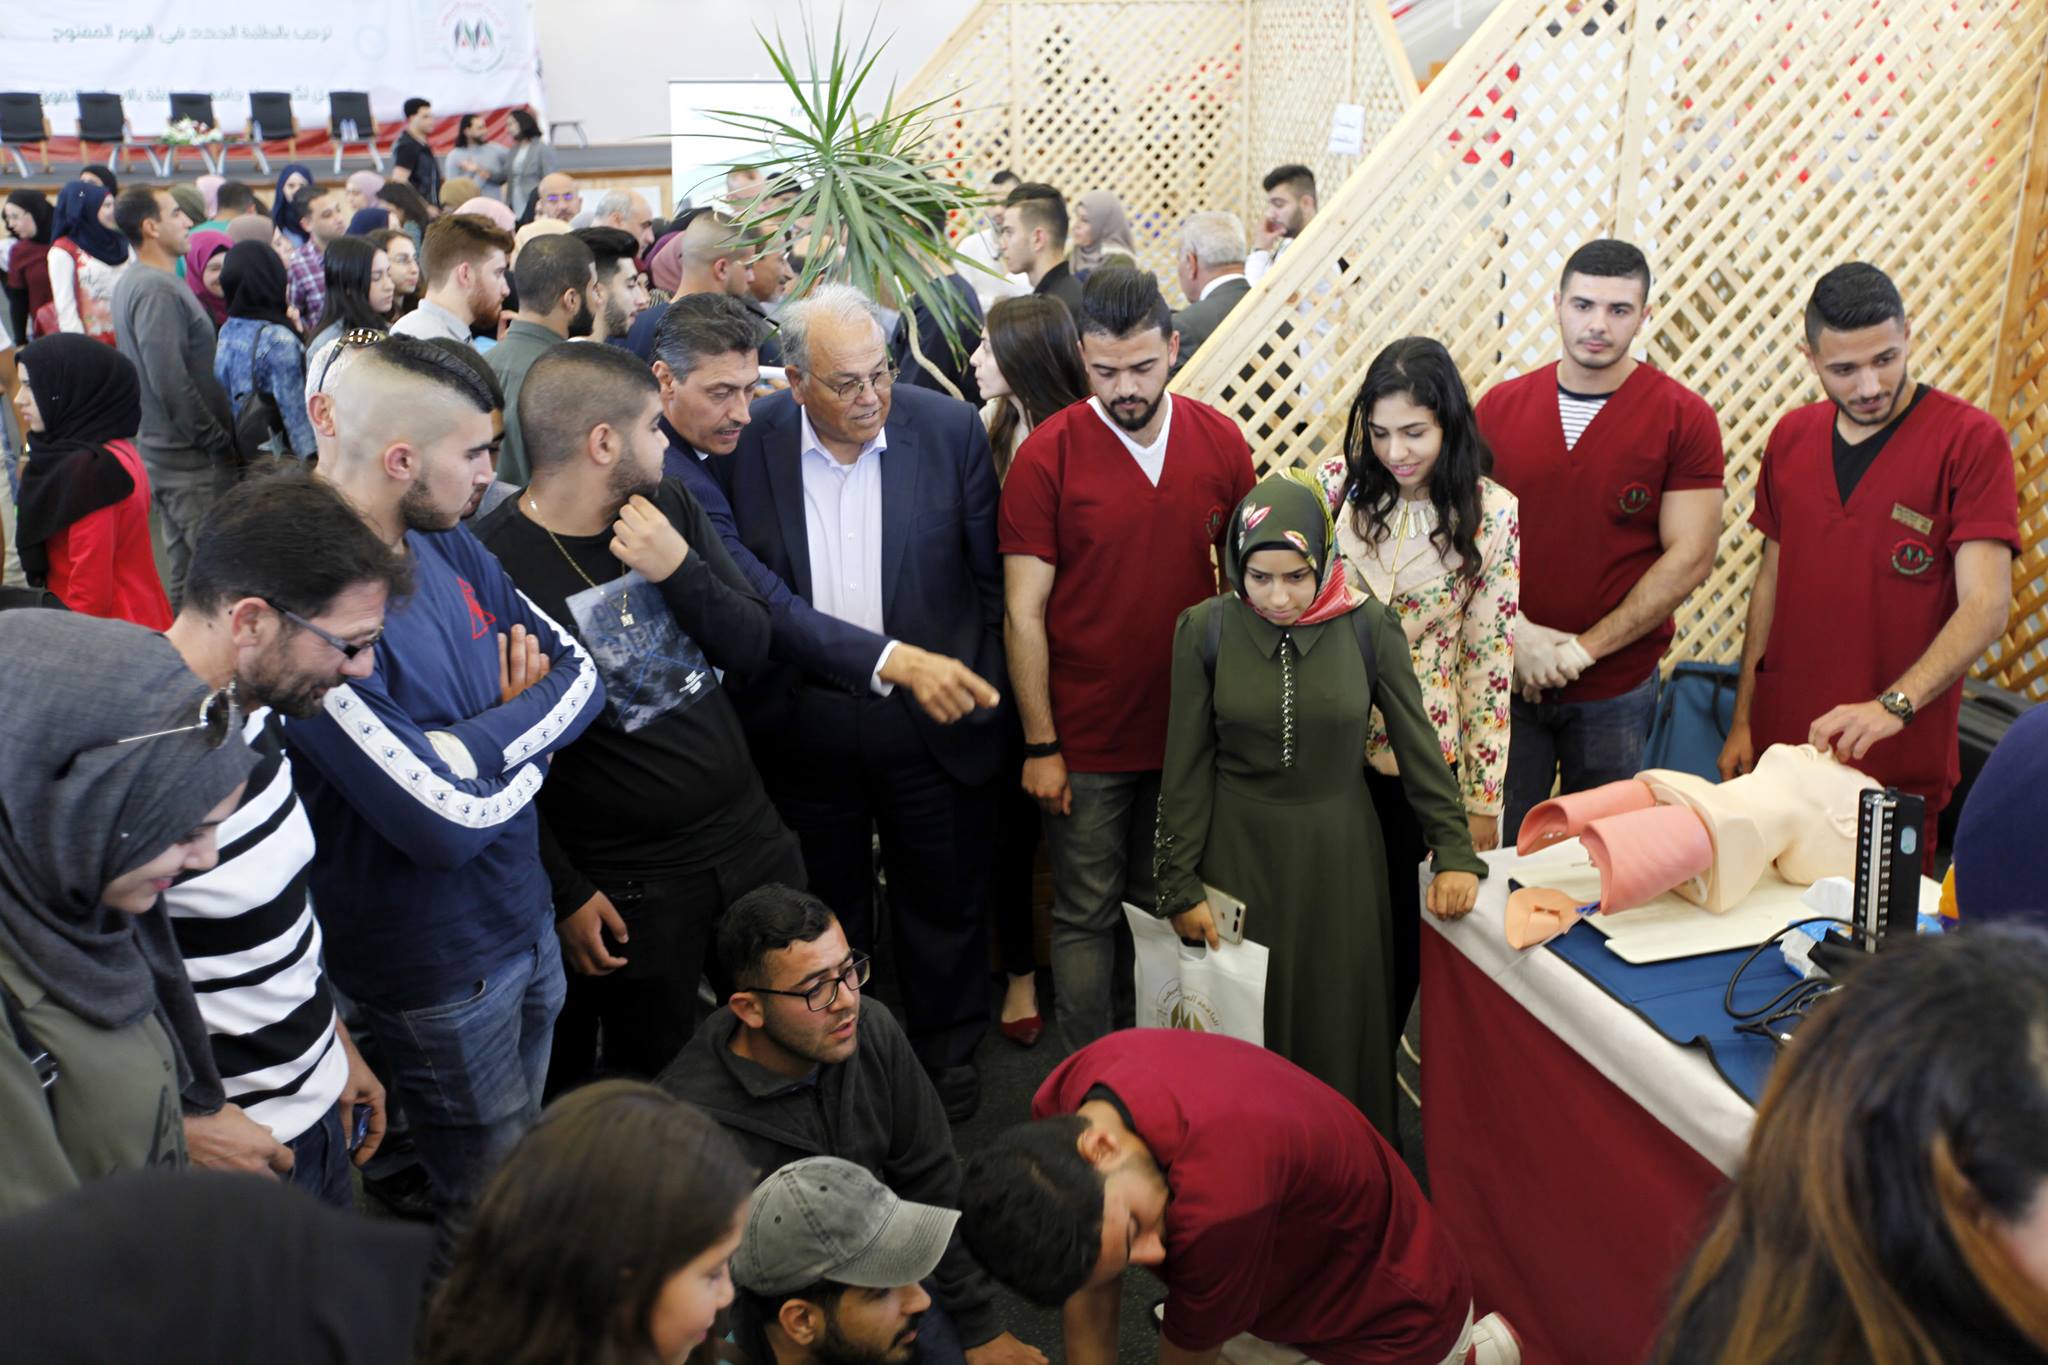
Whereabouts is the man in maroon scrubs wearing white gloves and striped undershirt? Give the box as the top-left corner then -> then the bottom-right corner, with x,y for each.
1477,239 -> 1722,843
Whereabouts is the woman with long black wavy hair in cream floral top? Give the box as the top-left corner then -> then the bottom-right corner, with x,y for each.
1317,336 -> 1522,1033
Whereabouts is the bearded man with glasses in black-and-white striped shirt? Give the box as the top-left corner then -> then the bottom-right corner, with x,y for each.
164,475 -> 412,1207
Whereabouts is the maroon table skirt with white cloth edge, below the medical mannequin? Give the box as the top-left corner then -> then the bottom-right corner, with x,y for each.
1421,849 -> 1755,1365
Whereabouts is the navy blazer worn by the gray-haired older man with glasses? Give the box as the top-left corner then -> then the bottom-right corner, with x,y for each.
709,383 -> 1010,786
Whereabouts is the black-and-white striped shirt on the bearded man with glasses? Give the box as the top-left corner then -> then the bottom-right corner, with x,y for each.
164,708 -> 348,1142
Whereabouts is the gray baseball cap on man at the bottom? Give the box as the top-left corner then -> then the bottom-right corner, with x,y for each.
733,1156 -> 961,1293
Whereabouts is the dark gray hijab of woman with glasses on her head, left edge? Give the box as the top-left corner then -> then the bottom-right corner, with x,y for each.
0,610 -> 256,1107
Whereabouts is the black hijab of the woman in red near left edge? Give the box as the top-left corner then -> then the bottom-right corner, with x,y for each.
16,332 -> 141,587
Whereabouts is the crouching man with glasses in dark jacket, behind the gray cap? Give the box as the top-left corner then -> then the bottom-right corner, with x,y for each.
659,886 -> 1044,1365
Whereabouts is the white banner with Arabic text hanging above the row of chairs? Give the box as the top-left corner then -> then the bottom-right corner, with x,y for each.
0,0 -> 541,137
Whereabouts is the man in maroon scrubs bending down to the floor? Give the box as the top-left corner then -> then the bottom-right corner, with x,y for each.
961,1029 -> 1522,1365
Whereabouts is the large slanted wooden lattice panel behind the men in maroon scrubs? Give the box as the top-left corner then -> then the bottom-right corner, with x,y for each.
1176,0 -> 2048,659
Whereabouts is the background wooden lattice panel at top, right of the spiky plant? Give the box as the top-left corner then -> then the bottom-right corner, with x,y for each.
895,0 -> 1415,301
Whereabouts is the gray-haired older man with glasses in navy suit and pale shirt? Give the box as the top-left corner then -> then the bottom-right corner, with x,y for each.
711,284 -> 1006,1115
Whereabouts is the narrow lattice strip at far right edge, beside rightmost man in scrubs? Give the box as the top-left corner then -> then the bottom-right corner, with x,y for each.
1985,66 -> 2048,702
